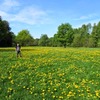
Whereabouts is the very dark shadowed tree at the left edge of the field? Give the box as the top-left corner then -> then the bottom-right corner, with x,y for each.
0,17 -> 14,47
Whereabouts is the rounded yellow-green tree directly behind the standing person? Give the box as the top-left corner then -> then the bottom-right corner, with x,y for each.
16,30 -> 34,46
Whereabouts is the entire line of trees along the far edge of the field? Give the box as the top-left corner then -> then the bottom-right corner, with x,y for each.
0,17 -> 100,47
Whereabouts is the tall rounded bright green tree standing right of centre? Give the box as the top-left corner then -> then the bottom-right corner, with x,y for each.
57,23 -> 73,47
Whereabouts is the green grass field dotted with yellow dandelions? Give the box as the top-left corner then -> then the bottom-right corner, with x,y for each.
0,47 -> 100,100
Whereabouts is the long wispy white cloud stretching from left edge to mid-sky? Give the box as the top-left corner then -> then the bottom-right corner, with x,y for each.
0,7 -> 51,25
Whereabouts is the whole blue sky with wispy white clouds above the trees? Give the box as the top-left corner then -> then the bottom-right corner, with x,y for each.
0,0 -> 100,38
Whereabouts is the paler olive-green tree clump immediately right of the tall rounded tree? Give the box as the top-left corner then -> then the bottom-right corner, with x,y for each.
73,23 -> 91,47
